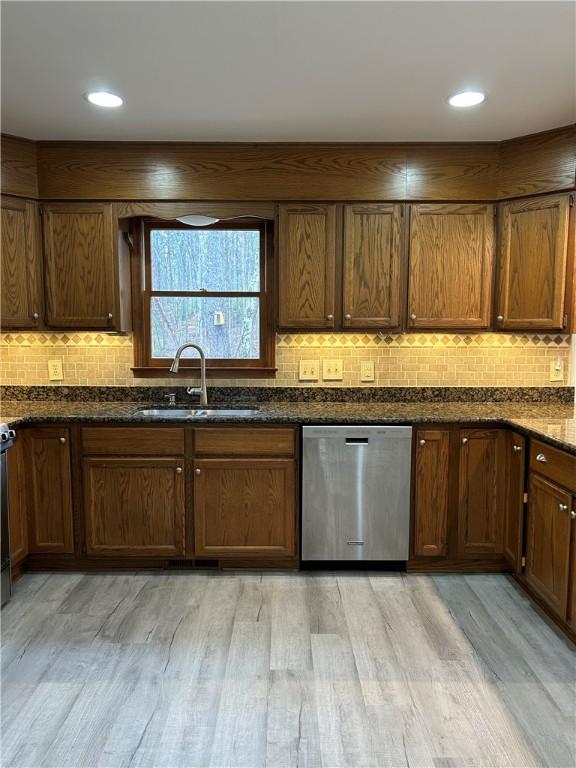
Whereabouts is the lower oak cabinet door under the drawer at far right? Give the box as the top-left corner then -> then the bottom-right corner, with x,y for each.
526,473 -> 572,619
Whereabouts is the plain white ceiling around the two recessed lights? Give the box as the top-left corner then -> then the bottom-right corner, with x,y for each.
2,0 -> 576,141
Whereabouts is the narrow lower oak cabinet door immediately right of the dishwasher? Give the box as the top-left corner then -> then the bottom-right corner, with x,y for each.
414,429 -> 450,557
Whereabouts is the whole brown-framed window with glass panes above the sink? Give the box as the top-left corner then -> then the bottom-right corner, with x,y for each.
136,219 -> 274,378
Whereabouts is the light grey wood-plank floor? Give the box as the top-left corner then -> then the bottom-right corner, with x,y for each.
2,573 -> 576,768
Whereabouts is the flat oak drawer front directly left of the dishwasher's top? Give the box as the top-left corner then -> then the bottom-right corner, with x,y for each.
194,427 -> 295,456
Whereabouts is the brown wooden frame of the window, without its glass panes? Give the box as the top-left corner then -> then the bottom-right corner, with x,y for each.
130,217 -> 277,379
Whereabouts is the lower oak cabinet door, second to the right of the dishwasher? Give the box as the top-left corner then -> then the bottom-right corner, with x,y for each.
458,429 -> 505,557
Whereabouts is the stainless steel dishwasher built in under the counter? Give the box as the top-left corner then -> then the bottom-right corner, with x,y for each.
302,426 -> 412,561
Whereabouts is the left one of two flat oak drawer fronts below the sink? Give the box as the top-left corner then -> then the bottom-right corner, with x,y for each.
82,427 -> 184,456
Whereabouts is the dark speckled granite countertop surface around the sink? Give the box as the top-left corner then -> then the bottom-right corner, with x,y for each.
0,400 -> 576,455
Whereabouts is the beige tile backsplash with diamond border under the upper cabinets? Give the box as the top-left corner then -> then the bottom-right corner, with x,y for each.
0,332 -> 573,387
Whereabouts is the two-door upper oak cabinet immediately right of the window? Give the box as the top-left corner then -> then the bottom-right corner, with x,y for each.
278,203 -> 405,329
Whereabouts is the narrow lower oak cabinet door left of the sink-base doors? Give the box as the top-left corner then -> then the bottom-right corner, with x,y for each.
24,427 -> 74,553
